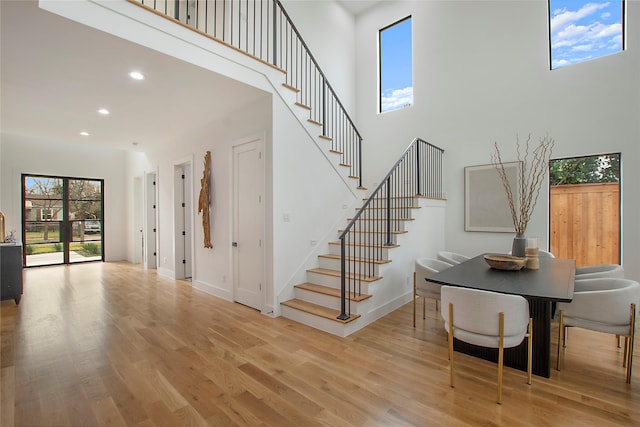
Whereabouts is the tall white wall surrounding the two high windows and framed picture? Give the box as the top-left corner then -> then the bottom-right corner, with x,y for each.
356,0 -> 640,279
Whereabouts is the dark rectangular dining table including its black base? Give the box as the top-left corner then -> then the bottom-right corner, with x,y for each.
426,254 -> 576,378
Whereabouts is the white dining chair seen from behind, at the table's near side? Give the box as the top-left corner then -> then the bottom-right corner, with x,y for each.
440,286 -> 533,403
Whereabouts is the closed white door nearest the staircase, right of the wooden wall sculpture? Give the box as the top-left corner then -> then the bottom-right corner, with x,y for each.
232,139 -> 264,310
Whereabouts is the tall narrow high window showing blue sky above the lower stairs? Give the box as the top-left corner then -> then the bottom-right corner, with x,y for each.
379,16 -> 413,113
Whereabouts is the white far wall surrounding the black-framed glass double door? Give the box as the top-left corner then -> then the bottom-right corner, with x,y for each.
0,133 -> 131,261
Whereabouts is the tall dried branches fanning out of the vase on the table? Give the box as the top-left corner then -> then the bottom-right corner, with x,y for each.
491,134 -> 555,234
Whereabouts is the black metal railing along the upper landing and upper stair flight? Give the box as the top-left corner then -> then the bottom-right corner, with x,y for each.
127,0 -> 362,187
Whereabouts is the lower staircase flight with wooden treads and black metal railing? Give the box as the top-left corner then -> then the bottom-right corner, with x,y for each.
280,139 -> 444,336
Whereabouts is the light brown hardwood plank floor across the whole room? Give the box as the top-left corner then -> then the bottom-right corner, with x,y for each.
0,263 -> 640,427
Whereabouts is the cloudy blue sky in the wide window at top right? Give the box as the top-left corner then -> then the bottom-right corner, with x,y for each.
549,0 -> 622,69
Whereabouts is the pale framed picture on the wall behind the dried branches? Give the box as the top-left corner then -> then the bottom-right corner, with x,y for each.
464,162 -> 520,233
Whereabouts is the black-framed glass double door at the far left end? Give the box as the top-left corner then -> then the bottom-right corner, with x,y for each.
22,175 -> 104,267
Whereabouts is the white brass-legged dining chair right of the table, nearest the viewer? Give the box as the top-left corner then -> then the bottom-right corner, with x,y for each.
556,278 -> 640,384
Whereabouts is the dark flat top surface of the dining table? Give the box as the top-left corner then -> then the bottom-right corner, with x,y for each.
429,254 -> 576,302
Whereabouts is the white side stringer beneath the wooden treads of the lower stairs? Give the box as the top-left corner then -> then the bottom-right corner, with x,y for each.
280,198 -> 446,337
